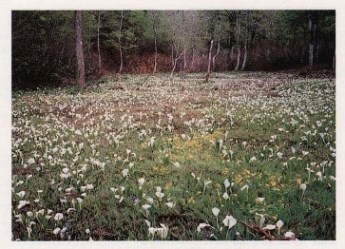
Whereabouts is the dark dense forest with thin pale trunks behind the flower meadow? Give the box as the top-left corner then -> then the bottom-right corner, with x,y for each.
12,10 -> 335,89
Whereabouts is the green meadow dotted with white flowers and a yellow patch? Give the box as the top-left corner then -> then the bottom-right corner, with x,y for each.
12,73 -> 335,240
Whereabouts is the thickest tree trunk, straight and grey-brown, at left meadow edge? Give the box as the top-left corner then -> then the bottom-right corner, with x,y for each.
74,11 -> 85,87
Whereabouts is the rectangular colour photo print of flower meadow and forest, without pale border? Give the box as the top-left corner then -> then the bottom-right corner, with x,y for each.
11,9 -> 337,241
